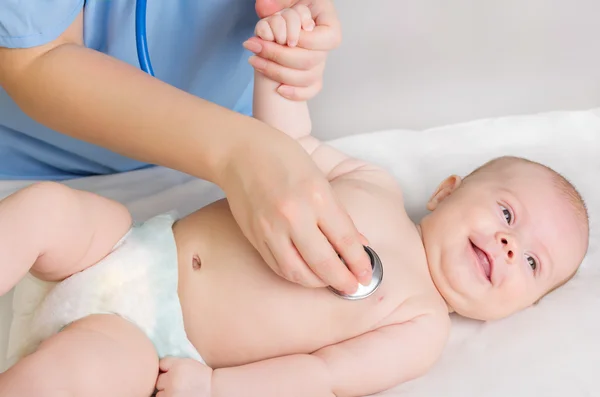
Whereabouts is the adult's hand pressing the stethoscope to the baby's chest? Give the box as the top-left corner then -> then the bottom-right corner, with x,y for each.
218,130 -> 372,293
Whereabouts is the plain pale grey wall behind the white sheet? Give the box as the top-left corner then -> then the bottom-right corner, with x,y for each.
310,0 -> 600,138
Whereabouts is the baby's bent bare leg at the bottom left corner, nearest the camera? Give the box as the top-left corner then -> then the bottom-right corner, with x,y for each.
0,315 -> 158,397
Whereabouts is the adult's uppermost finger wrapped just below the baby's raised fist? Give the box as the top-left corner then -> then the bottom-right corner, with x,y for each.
244,37 -> 327,70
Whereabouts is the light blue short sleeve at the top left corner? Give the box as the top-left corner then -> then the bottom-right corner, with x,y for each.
0,0 -> 85,48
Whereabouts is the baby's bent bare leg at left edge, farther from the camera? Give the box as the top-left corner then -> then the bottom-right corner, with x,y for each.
0,182 -> 131,296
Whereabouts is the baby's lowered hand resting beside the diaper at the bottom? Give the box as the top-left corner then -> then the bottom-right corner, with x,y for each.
156,357 -> 212,397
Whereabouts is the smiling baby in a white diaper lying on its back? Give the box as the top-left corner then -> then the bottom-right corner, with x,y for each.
0,8 -> 588,397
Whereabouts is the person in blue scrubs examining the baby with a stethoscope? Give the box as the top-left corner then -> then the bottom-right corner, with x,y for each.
0,0 -> 371,293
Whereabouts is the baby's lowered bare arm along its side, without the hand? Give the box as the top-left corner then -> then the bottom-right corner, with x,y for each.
211,315 -> 449,397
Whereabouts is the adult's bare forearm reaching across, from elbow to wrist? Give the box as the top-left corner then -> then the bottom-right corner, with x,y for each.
1,44 -> 281,182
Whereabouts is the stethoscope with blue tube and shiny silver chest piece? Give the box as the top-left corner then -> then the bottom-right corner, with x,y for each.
135,0 -> 383,300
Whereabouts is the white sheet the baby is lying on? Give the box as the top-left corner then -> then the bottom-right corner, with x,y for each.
0,109 -> 600,397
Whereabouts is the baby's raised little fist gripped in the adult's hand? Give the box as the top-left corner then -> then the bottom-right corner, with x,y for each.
254,5 -> 315,47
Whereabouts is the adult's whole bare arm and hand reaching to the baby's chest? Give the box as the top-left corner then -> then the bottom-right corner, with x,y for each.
0,8 -> 370,291
